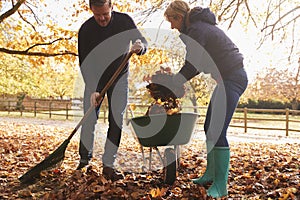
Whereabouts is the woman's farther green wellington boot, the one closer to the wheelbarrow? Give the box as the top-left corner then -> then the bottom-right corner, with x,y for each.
192,142 -> 215,185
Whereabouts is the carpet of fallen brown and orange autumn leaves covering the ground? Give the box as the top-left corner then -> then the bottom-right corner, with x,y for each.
0,119 -> 300,200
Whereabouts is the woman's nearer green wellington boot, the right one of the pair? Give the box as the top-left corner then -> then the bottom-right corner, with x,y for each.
207,147 -> 230,198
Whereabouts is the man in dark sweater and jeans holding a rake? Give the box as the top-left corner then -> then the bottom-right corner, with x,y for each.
77,0 -> 147,181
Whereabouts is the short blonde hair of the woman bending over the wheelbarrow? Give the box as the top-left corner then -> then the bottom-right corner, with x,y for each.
164,0 -> 190,19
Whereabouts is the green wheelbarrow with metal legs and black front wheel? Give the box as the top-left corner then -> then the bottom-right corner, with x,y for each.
129,113 -> 199,185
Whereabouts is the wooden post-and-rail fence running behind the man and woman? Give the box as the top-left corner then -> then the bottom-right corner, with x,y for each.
0,100 -> 300,136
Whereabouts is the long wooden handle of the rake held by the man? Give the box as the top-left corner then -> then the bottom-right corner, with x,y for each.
67,51 -> 133,140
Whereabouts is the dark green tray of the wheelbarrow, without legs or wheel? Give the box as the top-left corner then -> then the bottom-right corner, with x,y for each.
130,113 -> 198,147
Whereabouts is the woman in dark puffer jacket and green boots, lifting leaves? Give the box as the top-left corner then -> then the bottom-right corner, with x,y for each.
164,0 -> 248,198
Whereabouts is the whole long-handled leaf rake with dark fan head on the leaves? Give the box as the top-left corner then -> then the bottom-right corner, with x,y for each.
19,51 -> 133,183
